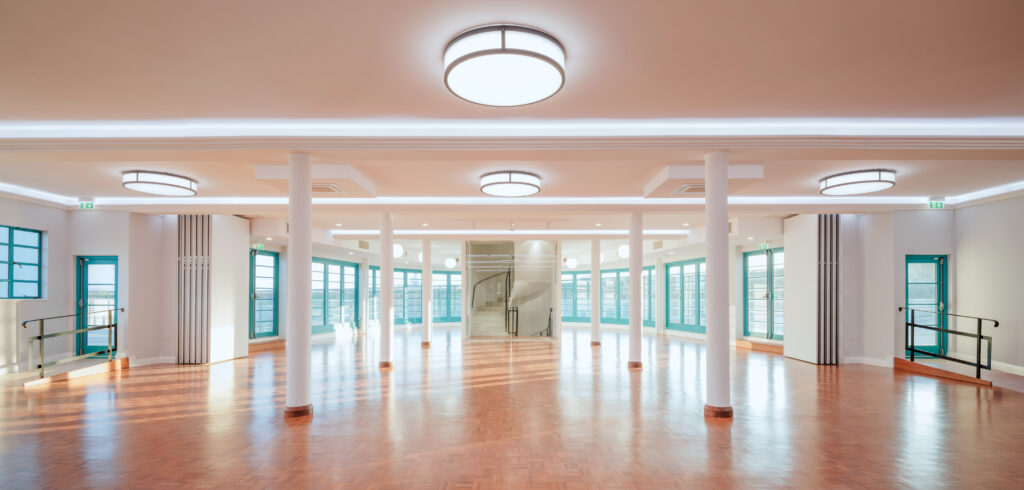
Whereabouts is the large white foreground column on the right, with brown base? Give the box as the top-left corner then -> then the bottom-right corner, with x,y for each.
705,151 -> 732,417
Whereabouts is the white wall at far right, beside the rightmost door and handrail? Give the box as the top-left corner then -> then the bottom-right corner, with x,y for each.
950,196 -> 1024,373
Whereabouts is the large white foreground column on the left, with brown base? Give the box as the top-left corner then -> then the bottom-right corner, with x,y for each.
285,153 -> 313,416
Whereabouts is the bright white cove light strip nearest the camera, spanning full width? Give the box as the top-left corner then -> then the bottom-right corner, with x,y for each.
6,118 -> 1024,139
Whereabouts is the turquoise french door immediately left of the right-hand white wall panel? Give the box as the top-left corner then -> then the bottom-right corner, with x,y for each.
743,248 -> 785,340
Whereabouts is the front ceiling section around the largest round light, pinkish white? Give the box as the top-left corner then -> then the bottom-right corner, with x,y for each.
0,0 -> 1024,120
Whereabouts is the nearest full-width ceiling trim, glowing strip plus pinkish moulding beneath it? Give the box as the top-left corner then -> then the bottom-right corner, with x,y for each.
0,118 -> 1024,150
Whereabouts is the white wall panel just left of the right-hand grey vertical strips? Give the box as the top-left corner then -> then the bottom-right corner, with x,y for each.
783,215 -> 818,363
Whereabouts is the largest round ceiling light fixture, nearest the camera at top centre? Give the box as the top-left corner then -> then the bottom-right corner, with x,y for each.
444,25 -> 565,107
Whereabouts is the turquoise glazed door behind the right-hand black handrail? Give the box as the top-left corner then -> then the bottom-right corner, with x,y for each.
906,255 -> 948,355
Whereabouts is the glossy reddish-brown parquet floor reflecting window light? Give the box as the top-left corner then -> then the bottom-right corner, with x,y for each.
0,328 -> 1024,489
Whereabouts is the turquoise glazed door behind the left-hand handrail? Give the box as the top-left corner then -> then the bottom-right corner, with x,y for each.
75,256 -> 118,355
